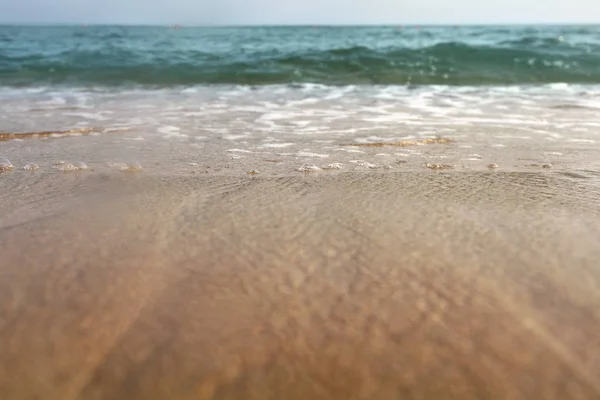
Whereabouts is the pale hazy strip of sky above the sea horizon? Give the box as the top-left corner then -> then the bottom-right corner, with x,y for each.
0,0 -> 600,25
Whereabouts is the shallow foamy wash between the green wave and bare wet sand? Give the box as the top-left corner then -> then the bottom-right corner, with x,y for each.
0,84 -> 600,175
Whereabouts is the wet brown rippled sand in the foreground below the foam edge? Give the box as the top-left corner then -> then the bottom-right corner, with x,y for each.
0,169 -> 600,400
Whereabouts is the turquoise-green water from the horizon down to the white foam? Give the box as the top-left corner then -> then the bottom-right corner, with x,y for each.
0,26 -> 600,87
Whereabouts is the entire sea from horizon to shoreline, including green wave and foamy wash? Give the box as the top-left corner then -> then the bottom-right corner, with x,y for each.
0,25 -> 600,171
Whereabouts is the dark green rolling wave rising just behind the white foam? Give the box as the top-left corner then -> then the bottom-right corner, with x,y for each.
0,26 -> 600,86
